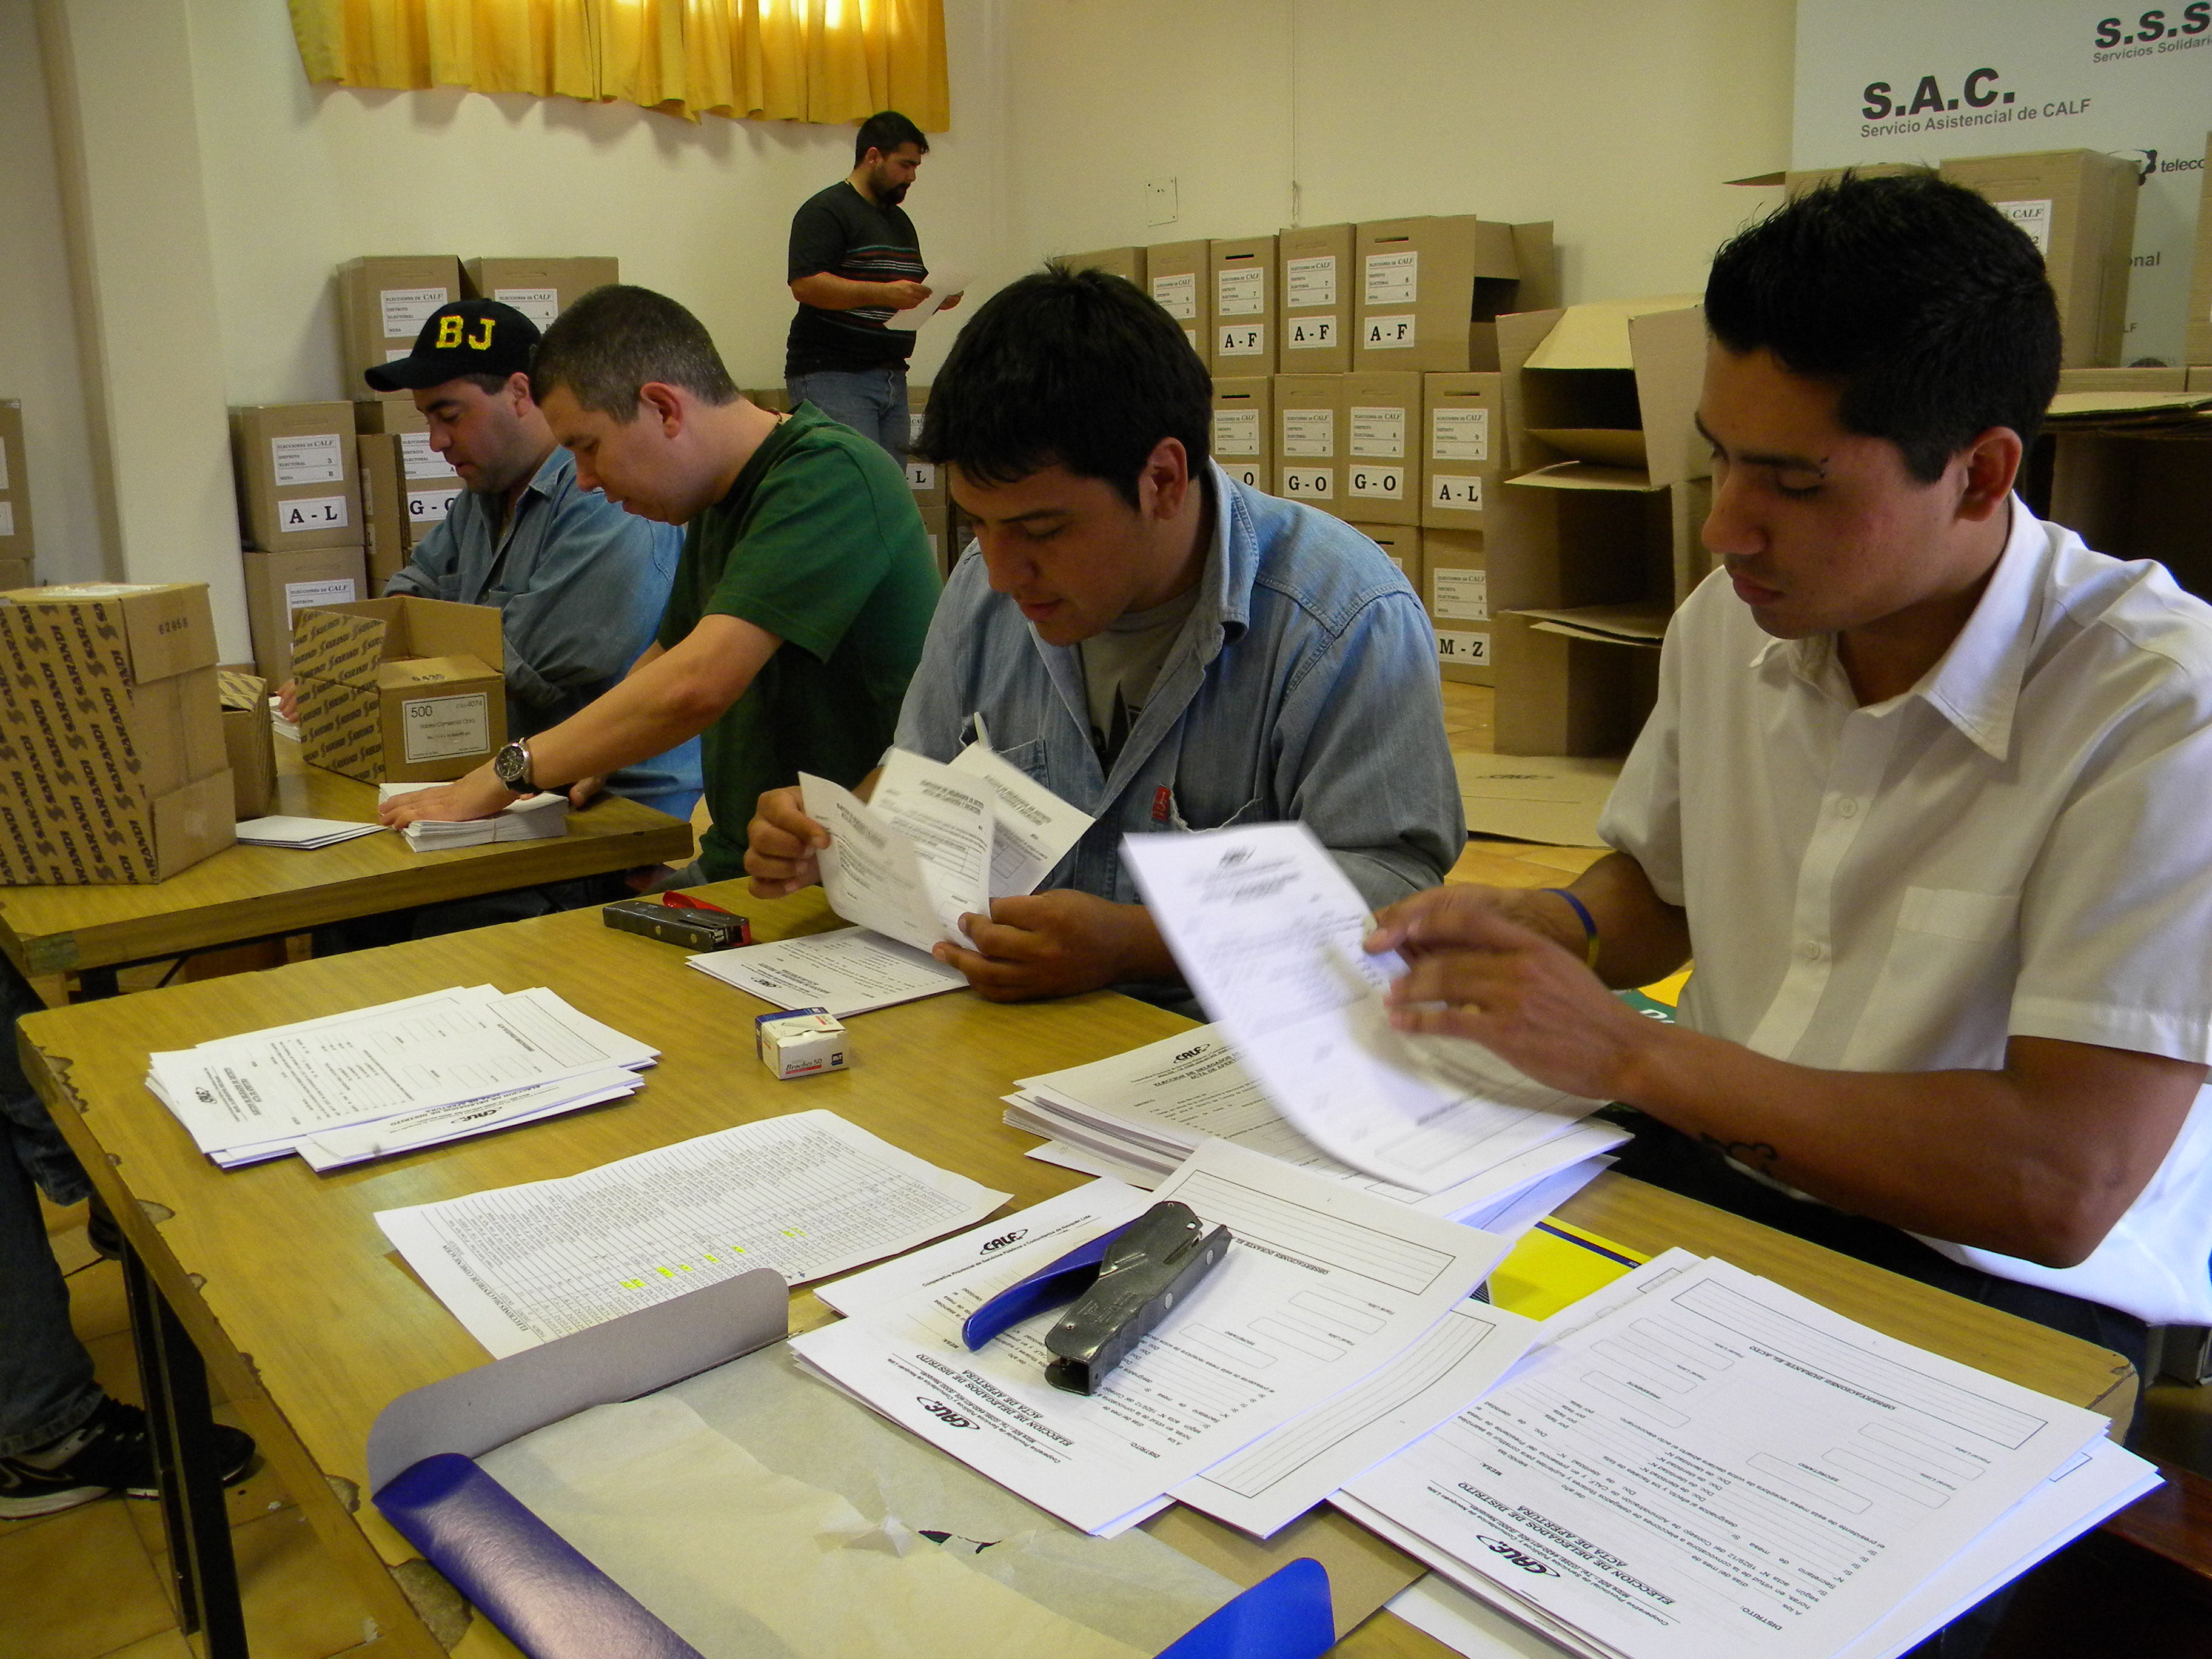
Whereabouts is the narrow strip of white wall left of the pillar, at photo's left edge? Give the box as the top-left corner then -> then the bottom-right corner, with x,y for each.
0,0 -> 113,581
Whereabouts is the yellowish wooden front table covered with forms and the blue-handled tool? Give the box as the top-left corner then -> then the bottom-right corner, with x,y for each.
20,898 -> 2133,1659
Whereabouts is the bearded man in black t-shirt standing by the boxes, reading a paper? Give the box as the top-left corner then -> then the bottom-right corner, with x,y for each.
783,109 -> 960,467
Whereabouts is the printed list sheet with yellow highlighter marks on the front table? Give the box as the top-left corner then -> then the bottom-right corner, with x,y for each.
376,1110 -> 1008,1358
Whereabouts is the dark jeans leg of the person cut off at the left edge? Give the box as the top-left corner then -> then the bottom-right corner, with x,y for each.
0,958 -> 102,1458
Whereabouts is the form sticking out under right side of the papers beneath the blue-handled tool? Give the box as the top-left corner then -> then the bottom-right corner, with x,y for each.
1172,1301 -> 1542,1537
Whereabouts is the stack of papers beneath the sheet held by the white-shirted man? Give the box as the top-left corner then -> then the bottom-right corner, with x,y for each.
1007,1027 -> 1628,1236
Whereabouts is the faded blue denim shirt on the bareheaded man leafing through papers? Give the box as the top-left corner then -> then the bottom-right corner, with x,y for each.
898,467 -> 1467,907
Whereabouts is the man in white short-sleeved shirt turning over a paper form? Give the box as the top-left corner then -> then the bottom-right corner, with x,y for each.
1373,177 -> 2212,1389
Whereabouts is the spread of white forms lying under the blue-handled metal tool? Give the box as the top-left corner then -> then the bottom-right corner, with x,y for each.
792,1141 -> 1540,1537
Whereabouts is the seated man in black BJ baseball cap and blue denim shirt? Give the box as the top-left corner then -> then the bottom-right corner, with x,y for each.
317,298 -> 699,951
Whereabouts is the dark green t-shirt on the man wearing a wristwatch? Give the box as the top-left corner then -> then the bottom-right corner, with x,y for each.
662,403 -> 938,880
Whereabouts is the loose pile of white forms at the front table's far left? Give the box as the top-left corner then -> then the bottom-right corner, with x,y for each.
146,984 -> 659,1170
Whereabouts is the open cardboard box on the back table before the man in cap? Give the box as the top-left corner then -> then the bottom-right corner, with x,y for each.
292,595 -> 506,783
